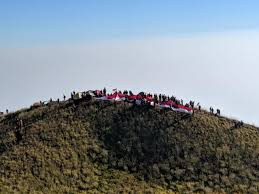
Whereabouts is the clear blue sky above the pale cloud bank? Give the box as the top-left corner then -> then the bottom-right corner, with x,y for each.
0,0 -> 259,47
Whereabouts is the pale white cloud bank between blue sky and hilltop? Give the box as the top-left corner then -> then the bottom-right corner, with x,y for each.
0,32 -> 259,125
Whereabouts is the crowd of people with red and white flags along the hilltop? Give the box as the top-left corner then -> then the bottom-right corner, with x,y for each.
0,88 -> 223,116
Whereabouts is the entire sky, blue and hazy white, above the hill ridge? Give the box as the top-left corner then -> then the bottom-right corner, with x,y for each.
0,0 -> 259,126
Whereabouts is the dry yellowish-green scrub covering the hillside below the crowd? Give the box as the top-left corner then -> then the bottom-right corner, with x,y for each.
0,101 -> 259,193
